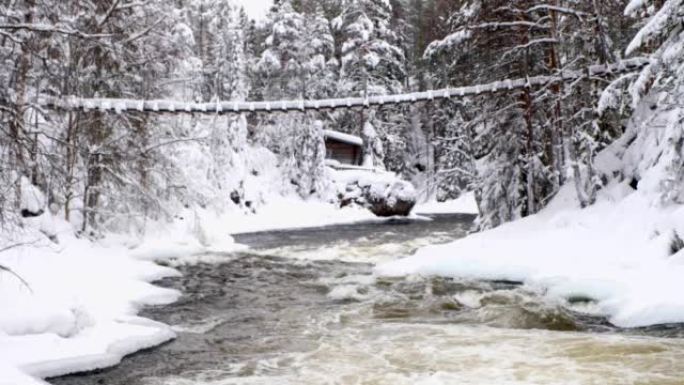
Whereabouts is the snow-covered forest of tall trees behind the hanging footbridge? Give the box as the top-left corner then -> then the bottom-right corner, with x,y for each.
0,0 -> 682,236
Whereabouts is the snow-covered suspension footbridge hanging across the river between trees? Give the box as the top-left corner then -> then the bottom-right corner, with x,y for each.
38,58 -> 649,114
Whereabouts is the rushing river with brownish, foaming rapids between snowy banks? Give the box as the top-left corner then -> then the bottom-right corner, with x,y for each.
50,215 -> 684,385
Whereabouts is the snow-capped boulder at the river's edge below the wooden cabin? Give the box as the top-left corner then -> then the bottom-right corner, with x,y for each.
333,169 -> 417,217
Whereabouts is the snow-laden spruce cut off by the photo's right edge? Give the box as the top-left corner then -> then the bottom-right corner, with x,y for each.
618,0 -> 684,204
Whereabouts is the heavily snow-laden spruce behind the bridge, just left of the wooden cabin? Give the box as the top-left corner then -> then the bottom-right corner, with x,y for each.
257,0 -> 335,197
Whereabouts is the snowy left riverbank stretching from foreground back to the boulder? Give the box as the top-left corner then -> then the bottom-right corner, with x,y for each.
0,199 -> 373,385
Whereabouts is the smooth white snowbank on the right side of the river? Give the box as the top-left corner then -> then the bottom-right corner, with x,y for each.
376,182 -> 684,327
